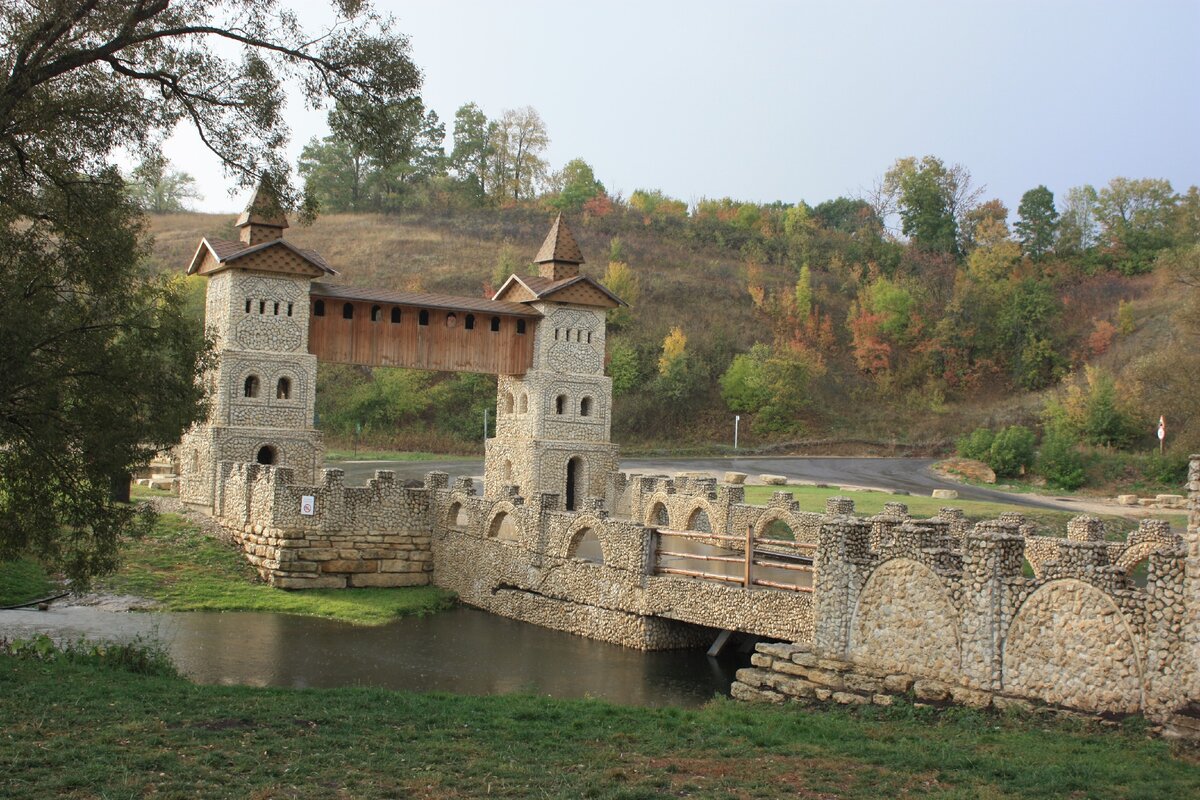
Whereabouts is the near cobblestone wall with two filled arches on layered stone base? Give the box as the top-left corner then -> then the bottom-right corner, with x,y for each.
733,456 -> 1200,735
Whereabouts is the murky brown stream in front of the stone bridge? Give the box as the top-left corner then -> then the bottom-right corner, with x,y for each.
0,607 -> 745,705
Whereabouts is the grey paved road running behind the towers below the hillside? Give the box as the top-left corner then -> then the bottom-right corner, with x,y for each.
329,456 -> 1070,510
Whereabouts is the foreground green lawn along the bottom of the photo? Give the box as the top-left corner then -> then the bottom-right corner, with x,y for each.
0,655 -> 1200,800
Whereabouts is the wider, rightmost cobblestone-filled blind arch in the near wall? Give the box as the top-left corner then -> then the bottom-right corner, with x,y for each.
1001,578 -> 1144,714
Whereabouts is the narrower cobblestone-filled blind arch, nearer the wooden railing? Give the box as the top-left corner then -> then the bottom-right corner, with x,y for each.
848,558 -> 962,680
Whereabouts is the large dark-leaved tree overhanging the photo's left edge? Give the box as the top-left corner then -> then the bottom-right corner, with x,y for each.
0,0 -> 419,579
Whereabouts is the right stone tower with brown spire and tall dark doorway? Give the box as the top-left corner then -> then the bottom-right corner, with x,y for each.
484,215 -> 624,510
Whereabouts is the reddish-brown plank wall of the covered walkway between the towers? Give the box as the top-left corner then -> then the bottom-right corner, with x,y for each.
308,296 -> 538,375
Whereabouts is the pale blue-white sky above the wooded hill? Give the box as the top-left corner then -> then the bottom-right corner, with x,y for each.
167,0 -> 1200,215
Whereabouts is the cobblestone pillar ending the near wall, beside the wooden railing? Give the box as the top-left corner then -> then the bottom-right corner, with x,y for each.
812,520 -> 871,658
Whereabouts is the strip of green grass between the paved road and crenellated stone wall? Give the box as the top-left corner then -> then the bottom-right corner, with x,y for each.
746,486 -> 1186,535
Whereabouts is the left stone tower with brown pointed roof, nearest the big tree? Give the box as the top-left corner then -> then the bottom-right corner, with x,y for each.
178,186 -> 335,509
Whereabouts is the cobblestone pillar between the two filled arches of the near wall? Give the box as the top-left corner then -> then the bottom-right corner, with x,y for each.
961,519 -> 1025,690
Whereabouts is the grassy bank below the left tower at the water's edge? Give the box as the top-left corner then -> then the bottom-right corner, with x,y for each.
98,513 -> 452,625
